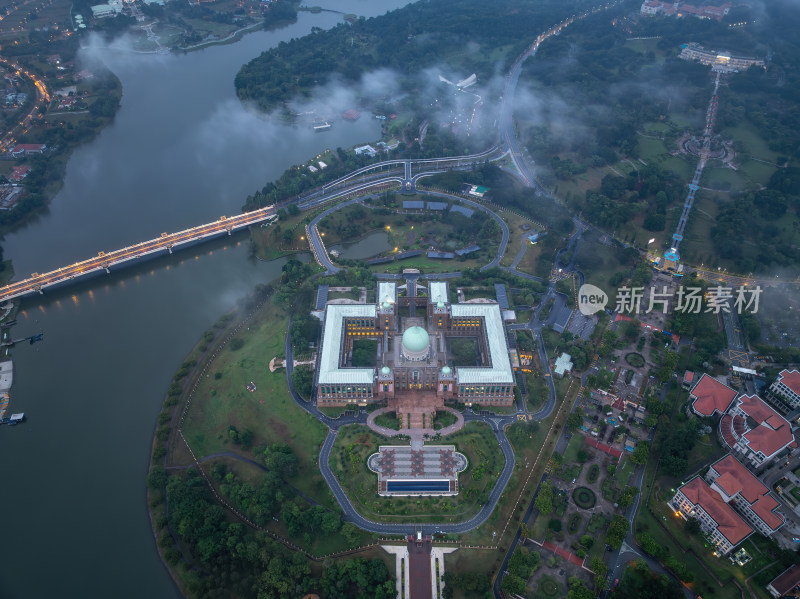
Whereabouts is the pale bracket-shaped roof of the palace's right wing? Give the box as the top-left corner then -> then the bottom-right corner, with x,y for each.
450,304 -> 514,385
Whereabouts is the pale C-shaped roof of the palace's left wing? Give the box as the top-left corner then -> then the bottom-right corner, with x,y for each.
318,304 -> 376,385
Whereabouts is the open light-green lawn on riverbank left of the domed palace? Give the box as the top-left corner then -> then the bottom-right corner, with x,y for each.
183,302 -> 334,506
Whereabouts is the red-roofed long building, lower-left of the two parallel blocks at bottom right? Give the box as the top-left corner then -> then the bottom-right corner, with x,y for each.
668,476 -> 753,555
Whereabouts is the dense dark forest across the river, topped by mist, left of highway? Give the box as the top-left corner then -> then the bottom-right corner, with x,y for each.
235,0 -> 592,111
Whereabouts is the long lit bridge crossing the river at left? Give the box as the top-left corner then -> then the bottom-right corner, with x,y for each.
0,206 -> 276,301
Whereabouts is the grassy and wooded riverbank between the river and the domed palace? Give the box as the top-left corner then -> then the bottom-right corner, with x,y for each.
147,282 -> 395,598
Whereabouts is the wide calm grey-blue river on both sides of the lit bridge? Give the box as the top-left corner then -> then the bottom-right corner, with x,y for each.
0,0 -> 406,599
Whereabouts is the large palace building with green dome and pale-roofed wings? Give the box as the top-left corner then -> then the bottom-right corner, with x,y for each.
316,281 -> 514,424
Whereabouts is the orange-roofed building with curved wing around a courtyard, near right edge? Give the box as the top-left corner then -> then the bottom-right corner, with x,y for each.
719,395 -> 797,468
